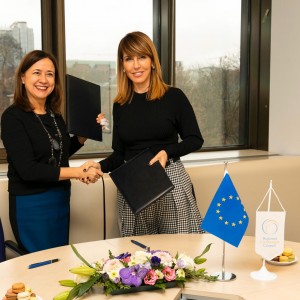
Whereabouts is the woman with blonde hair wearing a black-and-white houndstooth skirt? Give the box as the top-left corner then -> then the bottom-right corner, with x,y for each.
86,32 -> 204,236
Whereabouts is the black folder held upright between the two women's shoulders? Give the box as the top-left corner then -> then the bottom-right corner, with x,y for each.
66,74 -> 102,141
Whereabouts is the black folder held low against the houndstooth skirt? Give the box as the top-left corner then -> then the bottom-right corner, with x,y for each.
109,149 -> 174,214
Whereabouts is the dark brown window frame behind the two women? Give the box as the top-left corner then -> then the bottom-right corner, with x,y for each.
0,0 -> 272,163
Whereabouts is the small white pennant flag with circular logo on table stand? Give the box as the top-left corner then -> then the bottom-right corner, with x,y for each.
255,211 -> 286,260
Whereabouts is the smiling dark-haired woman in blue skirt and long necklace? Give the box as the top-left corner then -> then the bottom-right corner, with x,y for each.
1,50 -> 101,252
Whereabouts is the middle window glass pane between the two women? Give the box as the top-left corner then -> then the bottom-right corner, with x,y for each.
65,0 -> 153,153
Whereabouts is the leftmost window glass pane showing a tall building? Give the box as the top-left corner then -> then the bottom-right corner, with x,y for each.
0,0 -> 42,148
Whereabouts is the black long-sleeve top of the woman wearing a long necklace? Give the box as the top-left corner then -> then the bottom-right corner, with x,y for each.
1,105 -> 82,195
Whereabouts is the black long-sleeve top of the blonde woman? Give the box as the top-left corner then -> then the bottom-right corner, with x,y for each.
100,87 -> 204,173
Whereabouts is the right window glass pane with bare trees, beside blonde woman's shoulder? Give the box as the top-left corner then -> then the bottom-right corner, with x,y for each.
175,0 -> 241,147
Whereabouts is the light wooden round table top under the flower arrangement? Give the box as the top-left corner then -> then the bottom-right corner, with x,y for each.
0,234 -> 300,300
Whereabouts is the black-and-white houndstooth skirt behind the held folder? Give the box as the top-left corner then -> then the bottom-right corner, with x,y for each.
117,160 -> 204,237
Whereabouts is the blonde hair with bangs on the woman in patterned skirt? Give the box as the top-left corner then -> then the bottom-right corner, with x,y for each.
114,31 -> 169,105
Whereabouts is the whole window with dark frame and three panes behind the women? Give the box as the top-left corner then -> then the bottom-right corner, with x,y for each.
0,0 -> 271,162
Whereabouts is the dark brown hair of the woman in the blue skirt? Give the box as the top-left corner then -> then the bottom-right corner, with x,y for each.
14,50 -> 63,114
